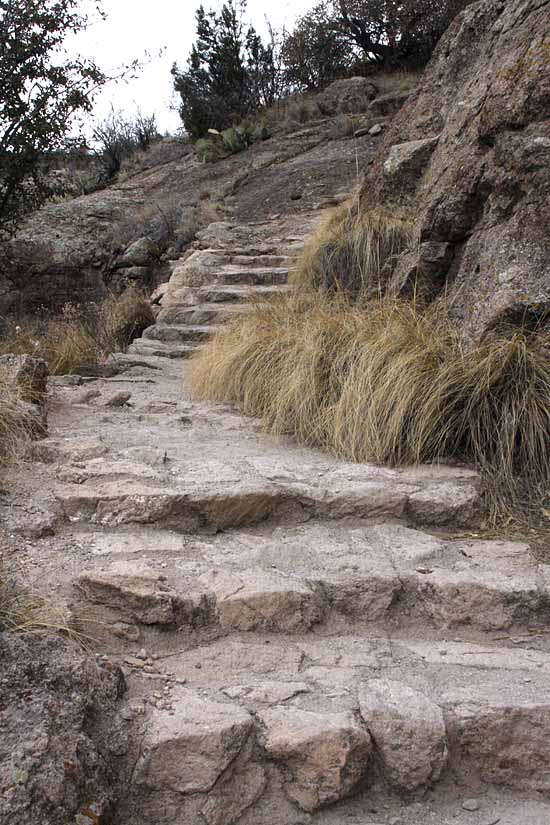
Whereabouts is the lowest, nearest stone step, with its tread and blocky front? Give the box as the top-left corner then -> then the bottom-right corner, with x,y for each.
116,636 -> 550,825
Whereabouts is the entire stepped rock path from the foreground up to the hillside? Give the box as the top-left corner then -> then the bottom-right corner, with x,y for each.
3,215 -> 550,825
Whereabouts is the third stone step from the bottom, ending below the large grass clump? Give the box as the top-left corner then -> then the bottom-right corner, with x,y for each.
56,458 -> 481,532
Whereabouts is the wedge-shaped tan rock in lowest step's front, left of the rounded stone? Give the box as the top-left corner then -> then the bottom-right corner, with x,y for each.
260,707 -> 372,812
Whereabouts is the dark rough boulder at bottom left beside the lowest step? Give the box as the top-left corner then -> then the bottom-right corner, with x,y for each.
0,634 -> 128,825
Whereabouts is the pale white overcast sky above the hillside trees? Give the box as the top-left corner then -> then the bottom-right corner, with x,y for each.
70,0 -> 314,132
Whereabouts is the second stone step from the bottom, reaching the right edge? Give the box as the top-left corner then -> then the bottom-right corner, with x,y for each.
78,522 -> 550,633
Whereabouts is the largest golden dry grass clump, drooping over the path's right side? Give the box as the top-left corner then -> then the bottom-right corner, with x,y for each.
190,293 -> 550,514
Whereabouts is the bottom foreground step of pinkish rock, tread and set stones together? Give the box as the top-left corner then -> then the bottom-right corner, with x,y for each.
116,637 -> 550,825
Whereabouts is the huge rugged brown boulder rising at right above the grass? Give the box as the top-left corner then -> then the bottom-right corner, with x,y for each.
363,0 -> 550,341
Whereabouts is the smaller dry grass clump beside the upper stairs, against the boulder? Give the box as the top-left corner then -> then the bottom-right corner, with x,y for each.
293,204 -> 416,297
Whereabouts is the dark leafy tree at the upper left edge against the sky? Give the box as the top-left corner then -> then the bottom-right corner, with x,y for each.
0,0 -> 106,239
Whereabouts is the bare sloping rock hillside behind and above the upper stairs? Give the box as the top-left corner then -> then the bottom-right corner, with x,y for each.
0,78 -> 406,316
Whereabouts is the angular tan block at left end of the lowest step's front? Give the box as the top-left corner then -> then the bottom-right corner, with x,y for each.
134,691 -> 252,796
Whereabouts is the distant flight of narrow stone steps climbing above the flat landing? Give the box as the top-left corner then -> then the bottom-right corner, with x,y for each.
130,214 -> 318,358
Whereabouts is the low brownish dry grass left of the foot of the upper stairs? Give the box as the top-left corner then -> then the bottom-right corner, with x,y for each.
0,287 -> 154,375
